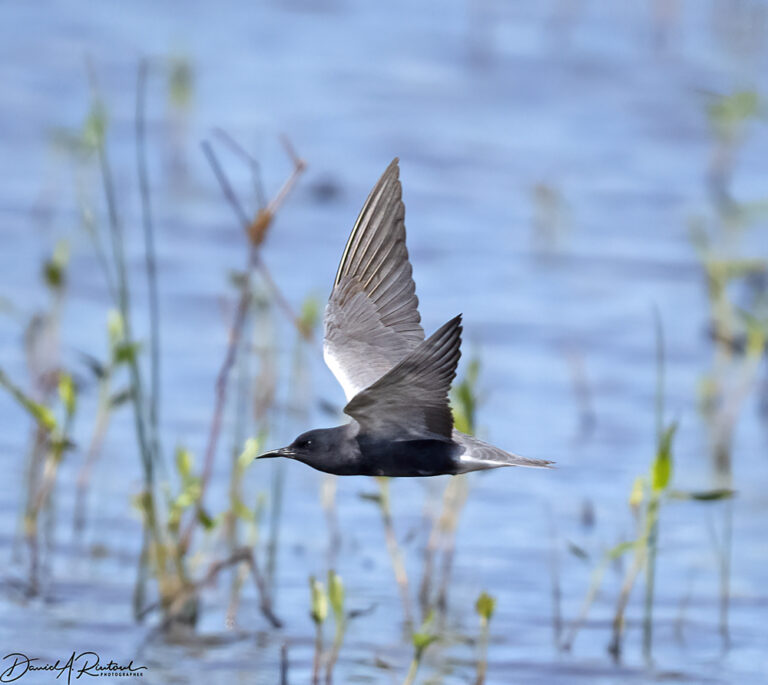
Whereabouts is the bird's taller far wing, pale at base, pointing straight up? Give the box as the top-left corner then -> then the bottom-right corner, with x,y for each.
323,158 -> 424,400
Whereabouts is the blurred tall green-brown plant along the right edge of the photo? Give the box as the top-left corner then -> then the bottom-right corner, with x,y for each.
691,90 -> 768,645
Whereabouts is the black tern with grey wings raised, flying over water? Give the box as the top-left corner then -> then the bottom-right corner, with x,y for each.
259,159 -> 552,476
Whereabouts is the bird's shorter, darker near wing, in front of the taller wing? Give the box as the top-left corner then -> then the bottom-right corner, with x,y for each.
344,315 -> 461,440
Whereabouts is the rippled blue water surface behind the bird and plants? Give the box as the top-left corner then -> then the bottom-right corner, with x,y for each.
0,0 -> 768,683
